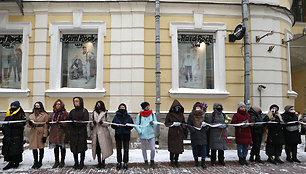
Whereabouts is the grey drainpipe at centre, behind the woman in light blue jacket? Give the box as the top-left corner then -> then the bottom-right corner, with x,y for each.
155,0 -> 160,142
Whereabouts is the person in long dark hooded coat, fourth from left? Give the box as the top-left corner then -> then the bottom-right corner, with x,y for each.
67,97 -> 89,170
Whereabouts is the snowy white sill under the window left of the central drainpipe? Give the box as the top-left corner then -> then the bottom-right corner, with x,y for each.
45,88 -> 106,98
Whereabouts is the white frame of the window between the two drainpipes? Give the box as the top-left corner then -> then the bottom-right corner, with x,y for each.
169,22 -> 229,98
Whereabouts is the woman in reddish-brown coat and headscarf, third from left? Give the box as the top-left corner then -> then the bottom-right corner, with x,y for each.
49,99 -> 68,168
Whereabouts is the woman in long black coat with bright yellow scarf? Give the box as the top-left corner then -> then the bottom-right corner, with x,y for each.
2,101 -> 26,170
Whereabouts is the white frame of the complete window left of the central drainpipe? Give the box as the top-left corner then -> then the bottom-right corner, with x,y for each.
46,19 -> 106,97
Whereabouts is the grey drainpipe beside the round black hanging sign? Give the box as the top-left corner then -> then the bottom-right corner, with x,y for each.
242,0 -> 250,109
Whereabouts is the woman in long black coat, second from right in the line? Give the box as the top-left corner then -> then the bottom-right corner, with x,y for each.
264,104 -> 285,164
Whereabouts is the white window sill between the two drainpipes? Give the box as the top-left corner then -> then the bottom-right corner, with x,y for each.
169,88 -> 230,98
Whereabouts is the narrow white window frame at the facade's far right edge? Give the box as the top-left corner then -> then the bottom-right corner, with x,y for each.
285,29 -> 298,99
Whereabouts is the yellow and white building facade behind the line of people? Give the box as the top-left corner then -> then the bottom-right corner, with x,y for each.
0,0 -> 299,113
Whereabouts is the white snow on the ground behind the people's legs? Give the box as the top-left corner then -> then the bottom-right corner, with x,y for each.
0,136 -> 306,172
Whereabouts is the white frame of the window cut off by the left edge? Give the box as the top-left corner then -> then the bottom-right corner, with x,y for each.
0,10 -> 32,97
